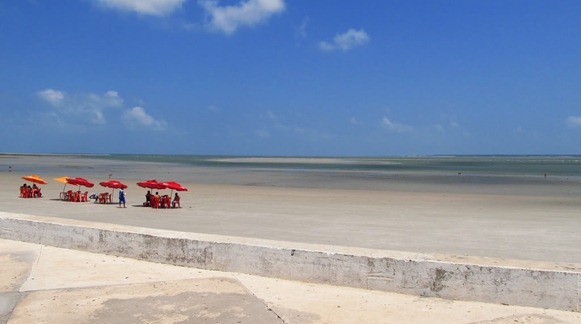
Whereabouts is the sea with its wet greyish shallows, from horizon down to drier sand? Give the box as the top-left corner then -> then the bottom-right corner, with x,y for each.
0,154 -> 581,196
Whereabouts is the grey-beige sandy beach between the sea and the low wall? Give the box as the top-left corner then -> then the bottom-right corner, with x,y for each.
0,156 -> 581,270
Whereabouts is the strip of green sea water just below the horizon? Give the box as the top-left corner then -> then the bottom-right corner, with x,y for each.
97,155 -> 581,177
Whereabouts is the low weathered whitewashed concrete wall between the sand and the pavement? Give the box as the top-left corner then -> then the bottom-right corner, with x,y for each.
0,213 -> 581,312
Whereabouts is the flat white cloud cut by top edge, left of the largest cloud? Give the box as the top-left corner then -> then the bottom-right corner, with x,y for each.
96,0 -> 186,16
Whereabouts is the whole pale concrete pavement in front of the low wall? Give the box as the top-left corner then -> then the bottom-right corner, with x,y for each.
0,239 -> 581,324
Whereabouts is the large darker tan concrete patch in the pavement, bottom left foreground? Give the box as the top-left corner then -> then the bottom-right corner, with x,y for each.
10,278 -> 283,323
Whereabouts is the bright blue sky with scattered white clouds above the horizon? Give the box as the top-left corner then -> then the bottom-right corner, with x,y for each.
0,0 -> 581,156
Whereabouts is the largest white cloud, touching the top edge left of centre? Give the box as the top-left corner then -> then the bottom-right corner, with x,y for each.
199,0 -> 285,35
